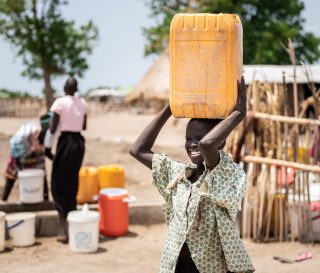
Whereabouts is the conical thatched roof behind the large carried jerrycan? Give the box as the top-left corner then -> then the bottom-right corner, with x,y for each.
126,53 -> 170,102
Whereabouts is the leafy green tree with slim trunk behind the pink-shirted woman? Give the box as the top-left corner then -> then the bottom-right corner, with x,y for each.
0,0 -> 98,109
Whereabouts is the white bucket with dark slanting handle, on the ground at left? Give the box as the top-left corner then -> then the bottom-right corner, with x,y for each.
6,212 -> 36,246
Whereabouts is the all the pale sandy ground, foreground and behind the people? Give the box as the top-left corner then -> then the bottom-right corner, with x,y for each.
0,112 -> 320,273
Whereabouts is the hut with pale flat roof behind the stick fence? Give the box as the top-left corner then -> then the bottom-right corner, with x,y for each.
244,65 -> 320,118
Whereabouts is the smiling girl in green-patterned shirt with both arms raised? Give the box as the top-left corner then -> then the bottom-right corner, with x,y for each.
130,12 -> 254,273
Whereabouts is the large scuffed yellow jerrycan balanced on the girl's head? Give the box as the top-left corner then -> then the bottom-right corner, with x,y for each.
170,13 -> 242,119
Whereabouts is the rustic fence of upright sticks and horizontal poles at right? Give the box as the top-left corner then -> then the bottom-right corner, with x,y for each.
227,79 -> 320,242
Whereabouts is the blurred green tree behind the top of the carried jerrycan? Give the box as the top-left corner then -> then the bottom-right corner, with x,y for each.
144,0 -> 320,64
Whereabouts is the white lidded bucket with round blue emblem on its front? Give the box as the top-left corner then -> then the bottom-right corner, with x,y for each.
67,204 -> 100,253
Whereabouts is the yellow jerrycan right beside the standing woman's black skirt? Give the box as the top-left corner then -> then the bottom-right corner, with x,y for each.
77,167 -> 99,204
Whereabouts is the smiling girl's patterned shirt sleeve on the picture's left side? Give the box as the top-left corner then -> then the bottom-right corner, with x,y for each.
152,153 -> 171,201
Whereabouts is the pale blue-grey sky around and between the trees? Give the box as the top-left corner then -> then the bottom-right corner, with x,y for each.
0,0 -> 320,94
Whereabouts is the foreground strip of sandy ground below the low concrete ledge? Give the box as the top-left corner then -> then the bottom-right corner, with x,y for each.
0,225 -> 320,273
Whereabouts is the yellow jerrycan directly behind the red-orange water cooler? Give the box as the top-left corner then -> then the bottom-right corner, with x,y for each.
98,165 -> 125,189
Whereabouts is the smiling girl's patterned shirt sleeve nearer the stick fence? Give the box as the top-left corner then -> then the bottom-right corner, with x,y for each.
207,155 -> 247,218
